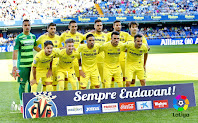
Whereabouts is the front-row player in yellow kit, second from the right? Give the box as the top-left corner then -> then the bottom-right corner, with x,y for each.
100,32 -> 125,88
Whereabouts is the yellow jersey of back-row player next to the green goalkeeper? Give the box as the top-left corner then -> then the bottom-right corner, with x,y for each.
36,34 -> 62,49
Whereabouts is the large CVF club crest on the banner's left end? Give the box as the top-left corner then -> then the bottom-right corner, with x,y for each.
24,92 -> 58,118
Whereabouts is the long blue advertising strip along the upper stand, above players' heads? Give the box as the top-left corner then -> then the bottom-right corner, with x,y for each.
0,14 -> 198,26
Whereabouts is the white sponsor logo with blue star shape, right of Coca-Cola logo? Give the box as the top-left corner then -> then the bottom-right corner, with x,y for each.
136,101 -> 152,110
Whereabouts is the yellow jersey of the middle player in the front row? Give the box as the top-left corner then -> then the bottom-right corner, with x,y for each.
78,44 -> 100,70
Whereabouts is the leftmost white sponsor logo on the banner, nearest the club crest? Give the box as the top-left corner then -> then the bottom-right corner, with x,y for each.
67,105 -> 83,115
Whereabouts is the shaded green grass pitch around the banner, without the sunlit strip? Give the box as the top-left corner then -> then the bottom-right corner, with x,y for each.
0,45 -> 198,123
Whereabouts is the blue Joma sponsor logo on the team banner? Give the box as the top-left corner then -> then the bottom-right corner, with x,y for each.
84,104 -> 101,114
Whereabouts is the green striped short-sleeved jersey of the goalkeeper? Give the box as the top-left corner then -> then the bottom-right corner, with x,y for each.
14,33 -> 36,67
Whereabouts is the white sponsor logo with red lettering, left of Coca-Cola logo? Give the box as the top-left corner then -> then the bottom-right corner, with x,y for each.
102,103 -> 118,112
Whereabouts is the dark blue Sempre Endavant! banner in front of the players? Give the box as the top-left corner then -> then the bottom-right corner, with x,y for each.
23,83 -> 196,118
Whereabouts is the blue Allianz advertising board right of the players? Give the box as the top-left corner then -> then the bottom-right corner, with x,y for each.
147,38 -> 198,45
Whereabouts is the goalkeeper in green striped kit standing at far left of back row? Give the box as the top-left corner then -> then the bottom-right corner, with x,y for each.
12,20 -> 40,112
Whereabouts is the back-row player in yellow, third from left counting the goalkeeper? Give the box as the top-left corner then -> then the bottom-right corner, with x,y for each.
61,20 -> 84,88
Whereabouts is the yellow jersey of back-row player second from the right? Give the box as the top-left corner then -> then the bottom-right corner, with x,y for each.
107,31 -> 130,43
